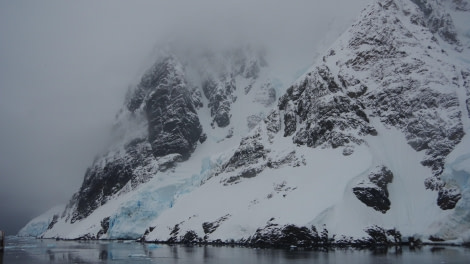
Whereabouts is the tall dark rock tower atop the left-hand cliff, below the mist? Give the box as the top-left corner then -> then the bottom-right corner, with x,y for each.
127,56 -> 202,159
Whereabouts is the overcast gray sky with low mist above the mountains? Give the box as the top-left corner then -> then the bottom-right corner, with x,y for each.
0,0 -> 369,234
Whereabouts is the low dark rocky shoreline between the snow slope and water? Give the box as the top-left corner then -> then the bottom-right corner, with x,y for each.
50,225 -> 470,252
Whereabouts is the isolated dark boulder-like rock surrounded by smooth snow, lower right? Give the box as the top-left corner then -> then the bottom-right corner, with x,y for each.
353,166 -> 393,214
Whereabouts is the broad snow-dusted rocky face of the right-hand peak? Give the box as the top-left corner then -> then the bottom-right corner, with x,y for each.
219,0 -> 468,209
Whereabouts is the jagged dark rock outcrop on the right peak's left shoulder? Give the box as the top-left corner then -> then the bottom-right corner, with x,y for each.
278,65 -> 377,148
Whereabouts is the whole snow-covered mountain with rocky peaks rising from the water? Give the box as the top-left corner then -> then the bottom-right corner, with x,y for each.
21,0 -> 470,248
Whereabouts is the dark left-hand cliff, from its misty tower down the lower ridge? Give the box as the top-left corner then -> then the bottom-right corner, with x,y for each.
69,56 -> 202,223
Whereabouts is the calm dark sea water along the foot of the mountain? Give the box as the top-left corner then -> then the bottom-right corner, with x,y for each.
0,237 -> 470,264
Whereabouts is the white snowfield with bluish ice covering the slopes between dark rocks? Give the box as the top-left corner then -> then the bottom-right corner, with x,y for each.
19,0 -> 470,243
